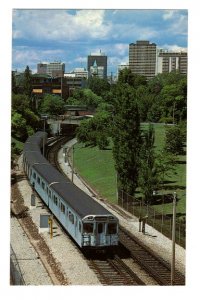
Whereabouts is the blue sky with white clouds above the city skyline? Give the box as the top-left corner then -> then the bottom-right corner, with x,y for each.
12,9 -> 188,76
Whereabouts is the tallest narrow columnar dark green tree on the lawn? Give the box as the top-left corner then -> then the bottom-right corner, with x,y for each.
112,84 -> 141,195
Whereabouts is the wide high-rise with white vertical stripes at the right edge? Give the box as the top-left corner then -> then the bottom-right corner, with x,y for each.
157,49 -> 187,74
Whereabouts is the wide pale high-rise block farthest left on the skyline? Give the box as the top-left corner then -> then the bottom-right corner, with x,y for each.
37,61 -> 65,77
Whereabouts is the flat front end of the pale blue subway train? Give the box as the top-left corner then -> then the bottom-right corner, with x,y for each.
82,215 -> 119,248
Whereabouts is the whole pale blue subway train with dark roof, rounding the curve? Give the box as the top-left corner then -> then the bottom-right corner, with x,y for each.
23,131 -> 119,249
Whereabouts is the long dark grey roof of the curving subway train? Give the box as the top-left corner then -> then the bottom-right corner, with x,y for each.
24,132 -> 111,218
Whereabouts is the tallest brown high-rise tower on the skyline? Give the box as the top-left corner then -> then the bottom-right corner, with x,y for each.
129,41 -> 157,80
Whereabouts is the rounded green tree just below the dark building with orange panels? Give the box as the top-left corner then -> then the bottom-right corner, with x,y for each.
39,94 -> 65,115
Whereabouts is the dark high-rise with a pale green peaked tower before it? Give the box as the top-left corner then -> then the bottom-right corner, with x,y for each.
87,51 -> 107,78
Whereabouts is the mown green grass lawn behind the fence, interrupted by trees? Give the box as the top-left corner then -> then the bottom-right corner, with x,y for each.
74,124 -> 186,214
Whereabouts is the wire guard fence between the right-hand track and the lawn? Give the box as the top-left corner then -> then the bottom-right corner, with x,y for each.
118,190 -> 186,248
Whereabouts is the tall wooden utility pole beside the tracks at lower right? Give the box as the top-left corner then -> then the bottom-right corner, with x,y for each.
171,192 -> 176,285
